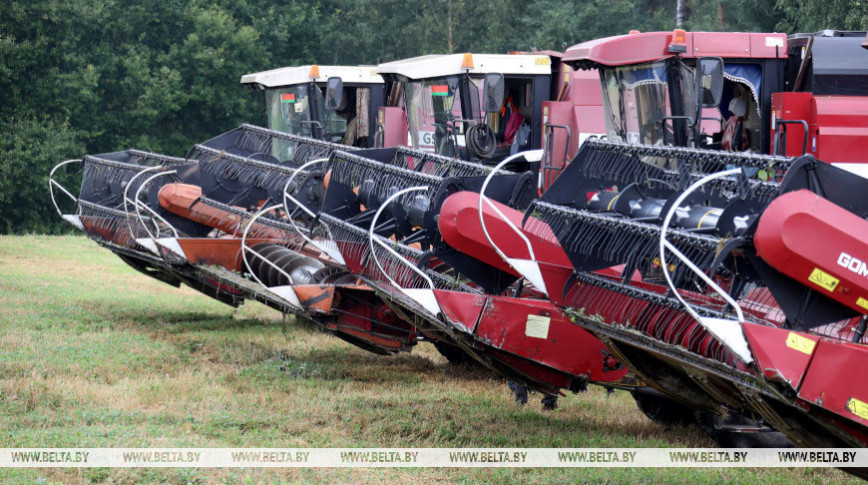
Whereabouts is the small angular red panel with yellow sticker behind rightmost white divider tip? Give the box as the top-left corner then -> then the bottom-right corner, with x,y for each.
743,323 -> 820,390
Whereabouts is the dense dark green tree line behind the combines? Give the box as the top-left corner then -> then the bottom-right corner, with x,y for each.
0,0 -> 856,233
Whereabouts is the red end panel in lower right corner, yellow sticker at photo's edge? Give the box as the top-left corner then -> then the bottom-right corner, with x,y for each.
799,339 -> 868,426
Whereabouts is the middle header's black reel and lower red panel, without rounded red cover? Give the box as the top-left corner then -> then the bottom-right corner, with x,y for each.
319,143 -> 629,394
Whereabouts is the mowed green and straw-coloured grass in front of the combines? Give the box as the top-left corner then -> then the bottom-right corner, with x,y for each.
0,236 -> 853,484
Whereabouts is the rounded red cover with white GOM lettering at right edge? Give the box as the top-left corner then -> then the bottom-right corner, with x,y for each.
754,190 -> 868,313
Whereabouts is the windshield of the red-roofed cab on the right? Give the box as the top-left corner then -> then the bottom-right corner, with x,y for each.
600,61 -> 695,145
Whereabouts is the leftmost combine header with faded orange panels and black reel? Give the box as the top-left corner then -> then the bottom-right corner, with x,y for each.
51,125 -> 415,353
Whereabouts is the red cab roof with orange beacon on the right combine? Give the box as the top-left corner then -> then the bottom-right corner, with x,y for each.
563,32 -> 787,66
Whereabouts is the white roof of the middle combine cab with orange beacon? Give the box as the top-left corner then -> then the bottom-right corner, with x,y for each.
377,54 -> 552,79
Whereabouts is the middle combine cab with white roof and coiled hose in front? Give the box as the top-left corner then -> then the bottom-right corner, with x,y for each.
377,54 -> 544,171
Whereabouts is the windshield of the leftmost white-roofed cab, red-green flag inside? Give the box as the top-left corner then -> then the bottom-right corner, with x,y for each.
265,83 -> 347,143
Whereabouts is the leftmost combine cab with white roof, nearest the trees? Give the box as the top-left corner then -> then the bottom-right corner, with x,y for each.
241,65 -> 384,148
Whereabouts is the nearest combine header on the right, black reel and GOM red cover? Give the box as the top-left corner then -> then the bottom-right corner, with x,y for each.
528,136 -> 868,447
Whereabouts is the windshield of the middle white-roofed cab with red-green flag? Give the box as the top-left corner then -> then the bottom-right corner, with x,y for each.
404,76 -> 483,157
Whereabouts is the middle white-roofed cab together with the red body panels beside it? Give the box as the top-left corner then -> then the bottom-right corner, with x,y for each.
377,51 -> 605,190
